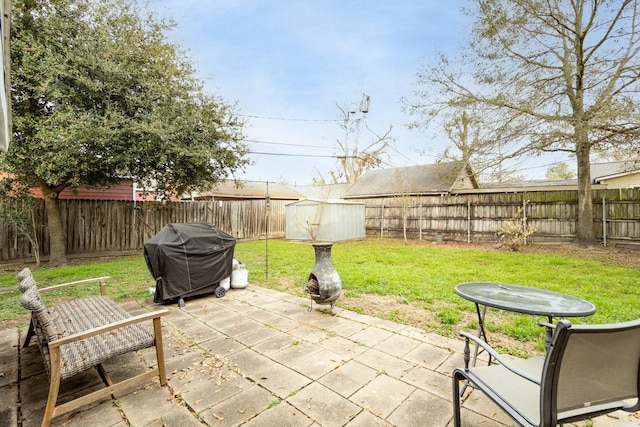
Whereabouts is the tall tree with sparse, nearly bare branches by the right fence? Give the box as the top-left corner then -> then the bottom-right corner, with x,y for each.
413,0 -> 640,246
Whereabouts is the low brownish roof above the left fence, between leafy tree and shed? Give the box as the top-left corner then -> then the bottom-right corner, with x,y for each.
185,180 -> 305,200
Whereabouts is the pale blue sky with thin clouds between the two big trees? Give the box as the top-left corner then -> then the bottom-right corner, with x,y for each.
150,0 -> 556,185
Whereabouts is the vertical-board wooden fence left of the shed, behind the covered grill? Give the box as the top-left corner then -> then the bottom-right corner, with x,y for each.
0,200 -> 286,260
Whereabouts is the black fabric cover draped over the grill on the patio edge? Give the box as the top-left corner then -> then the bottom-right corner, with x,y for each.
144,222 -> 236,303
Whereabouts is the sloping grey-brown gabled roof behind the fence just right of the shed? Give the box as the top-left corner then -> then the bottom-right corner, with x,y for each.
344,162 -> 469,199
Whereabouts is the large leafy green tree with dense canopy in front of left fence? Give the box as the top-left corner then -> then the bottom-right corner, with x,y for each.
2,0 -> 247,265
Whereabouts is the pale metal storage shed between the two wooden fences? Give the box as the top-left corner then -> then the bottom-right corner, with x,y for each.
285,199 -> 365,242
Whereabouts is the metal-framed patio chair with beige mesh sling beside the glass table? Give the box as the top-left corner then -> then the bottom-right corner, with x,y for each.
453,319 -> 640,427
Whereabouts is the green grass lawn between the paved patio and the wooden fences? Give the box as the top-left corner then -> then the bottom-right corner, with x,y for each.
0,238 -> 640,355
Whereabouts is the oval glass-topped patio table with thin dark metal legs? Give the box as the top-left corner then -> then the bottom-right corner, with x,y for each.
456,282 -> 596,366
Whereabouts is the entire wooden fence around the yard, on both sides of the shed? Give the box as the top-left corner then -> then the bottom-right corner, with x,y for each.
0,189 -> 640,260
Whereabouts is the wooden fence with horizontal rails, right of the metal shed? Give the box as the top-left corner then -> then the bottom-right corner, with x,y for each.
365,189 -> 640,244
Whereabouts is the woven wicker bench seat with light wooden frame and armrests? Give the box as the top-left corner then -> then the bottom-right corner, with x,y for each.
18,271 -> 169,427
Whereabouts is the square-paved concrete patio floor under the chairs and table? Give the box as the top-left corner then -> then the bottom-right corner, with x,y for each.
0,285 -> 640,427
